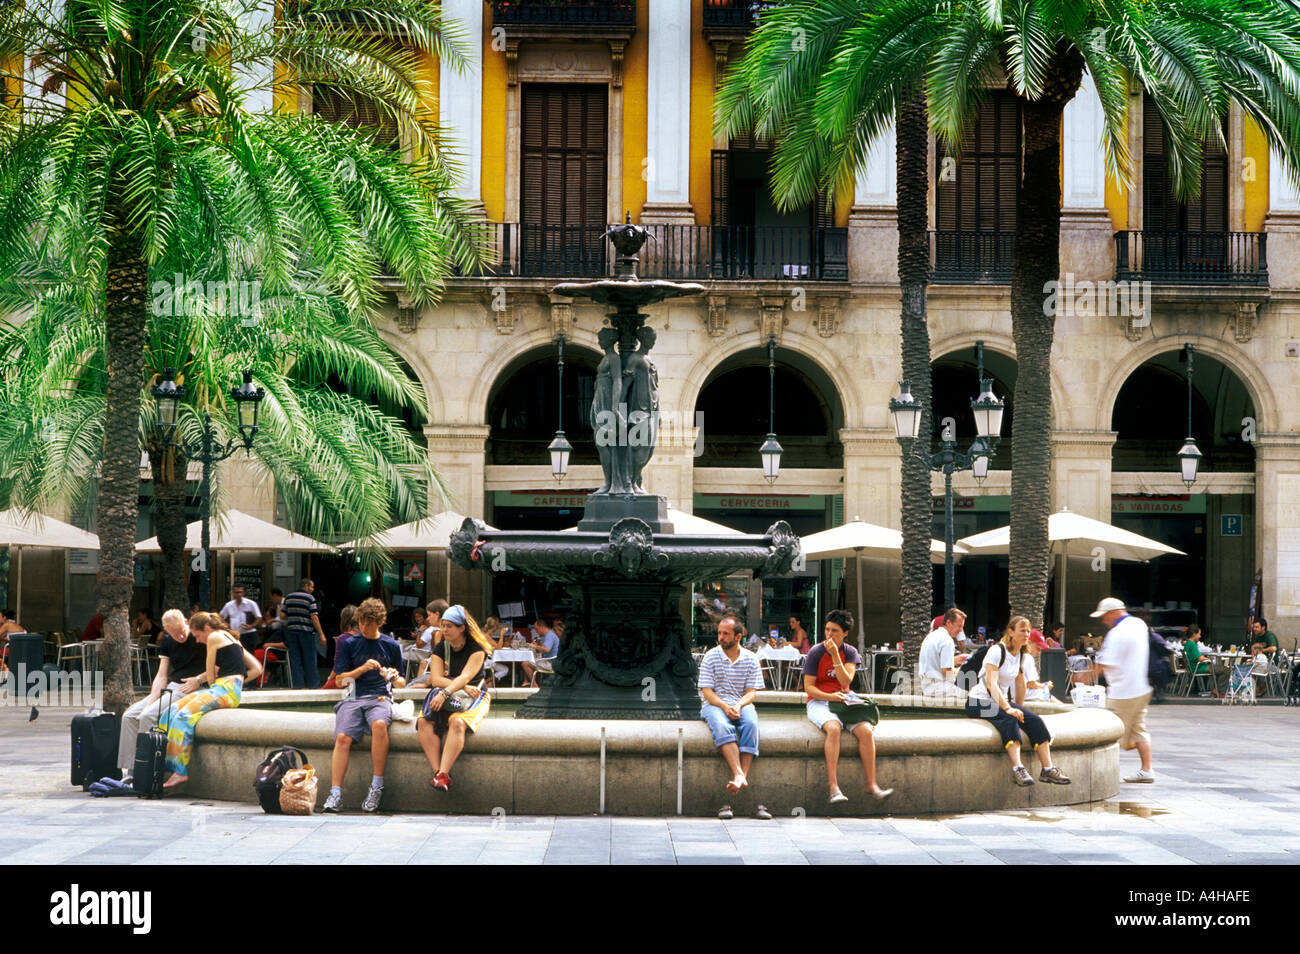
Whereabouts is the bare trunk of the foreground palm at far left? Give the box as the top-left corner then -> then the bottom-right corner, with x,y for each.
96,230 -> 148,714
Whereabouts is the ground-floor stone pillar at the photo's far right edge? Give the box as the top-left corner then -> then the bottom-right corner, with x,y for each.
1252,434 -> 1300,645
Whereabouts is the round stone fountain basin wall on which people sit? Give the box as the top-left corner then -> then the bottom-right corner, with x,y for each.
183,689 -> 1122,816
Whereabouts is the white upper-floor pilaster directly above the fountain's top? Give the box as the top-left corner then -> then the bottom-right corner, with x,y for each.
641,0 -> 696,225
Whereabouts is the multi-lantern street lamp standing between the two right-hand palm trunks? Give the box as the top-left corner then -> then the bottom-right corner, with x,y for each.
889,342 -> 1006,607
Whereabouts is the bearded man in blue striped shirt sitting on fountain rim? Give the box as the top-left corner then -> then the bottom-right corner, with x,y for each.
699,615 -> 772,820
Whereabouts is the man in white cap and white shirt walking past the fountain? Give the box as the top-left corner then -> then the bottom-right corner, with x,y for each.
1089,597 -> 1156,782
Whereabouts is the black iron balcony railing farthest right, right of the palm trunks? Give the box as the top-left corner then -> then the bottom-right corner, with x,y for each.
1115,231 -> 1269,285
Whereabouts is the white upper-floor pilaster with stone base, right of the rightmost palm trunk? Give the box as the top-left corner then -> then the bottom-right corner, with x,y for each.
1061,73 -> 1115,281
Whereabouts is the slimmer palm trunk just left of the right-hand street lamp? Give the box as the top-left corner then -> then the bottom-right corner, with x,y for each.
896,90 -> 935,660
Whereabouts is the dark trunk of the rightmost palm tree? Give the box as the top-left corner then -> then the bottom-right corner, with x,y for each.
1008,49 -> 1083,625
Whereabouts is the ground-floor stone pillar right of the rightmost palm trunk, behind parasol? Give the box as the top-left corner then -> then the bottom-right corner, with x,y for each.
1035,430 -> 1115,638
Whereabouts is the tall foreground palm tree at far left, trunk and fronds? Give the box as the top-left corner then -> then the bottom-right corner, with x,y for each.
0,0 -> 483,710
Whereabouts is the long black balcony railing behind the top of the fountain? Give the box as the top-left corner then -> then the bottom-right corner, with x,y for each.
462,222 -> 849,282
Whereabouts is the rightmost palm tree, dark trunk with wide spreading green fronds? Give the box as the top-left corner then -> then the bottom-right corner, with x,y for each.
719,0 -> 1300,619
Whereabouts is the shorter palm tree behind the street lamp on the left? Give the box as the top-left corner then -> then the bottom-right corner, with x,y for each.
0,261 -> 445,616
